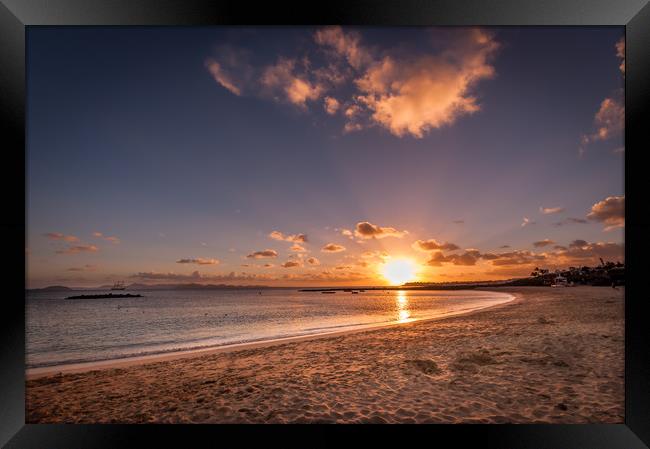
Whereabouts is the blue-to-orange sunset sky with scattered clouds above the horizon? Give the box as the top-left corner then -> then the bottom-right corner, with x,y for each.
25,27 -> 625,288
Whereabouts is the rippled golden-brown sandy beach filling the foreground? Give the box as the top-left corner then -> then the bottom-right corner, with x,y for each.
26,287 -> 624,423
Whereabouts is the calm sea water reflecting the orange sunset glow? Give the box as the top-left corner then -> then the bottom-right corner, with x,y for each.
26,289 -> 511,368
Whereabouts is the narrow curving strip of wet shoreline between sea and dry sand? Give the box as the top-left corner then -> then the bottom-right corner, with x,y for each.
25,290 -> 522,380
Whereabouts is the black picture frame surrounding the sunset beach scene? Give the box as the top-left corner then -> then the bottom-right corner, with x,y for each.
0,0 -> 650,449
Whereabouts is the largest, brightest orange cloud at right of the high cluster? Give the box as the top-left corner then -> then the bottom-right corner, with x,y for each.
355,29 -> 498,138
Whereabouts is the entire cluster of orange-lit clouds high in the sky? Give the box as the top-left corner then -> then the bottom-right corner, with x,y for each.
205,27 -> 499,138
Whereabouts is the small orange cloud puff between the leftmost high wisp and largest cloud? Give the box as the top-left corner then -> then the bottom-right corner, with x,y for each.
260,57 -> 324,108
